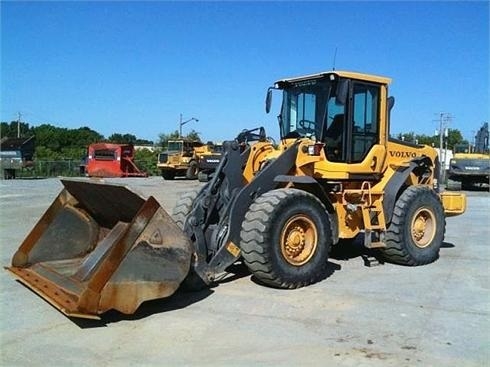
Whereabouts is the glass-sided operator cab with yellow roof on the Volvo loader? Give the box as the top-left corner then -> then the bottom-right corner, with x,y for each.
266,71 -> 390,163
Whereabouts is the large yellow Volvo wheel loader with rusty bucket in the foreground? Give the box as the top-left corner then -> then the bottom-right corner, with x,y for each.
8,71 -> 466,318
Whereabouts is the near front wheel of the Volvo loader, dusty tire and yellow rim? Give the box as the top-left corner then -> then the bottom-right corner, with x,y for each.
240,189 -> 332,288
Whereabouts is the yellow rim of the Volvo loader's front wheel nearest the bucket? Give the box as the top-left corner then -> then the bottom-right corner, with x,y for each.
281,215 -> 318,266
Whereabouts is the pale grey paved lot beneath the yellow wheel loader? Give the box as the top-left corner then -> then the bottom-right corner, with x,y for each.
0,177 -> 490,367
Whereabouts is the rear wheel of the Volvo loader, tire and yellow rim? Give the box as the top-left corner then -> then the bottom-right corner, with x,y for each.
380,186 -> 446,266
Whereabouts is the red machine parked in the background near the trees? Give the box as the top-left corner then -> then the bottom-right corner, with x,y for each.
86,143 -> 148,177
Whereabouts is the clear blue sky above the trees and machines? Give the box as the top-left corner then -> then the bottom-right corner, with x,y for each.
0,1 -> 490,144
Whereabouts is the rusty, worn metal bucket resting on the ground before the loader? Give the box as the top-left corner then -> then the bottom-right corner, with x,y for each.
6,180 -> 192,319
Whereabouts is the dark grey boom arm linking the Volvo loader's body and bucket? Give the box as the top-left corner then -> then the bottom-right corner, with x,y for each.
184,142 -> 298,284
